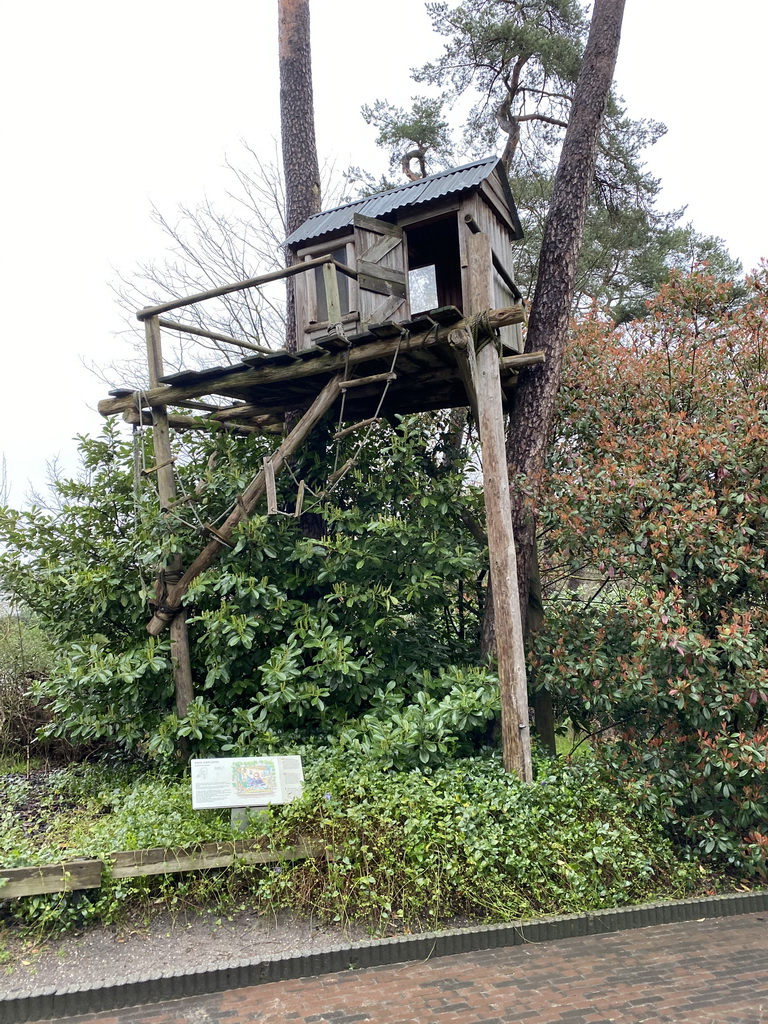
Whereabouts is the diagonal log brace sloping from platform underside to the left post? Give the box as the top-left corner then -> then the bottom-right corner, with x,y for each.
146,375 -> 342,636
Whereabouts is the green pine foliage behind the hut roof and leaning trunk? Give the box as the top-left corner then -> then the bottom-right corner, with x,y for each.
366,0 -> 741,323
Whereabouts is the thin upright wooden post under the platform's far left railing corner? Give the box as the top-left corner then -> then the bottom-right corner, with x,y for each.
145,316 -> 195,718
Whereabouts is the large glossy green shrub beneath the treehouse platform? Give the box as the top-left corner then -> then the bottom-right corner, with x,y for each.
0,418 -> 496,763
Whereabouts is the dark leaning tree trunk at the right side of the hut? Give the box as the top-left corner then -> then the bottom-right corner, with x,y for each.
507,0 -> 625,748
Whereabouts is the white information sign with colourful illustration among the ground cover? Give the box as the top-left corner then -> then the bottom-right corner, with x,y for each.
190,756 -> 304,811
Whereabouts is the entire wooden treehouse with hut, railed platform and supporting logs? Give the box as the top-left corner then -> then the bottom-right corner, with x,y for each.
98,157 -> 543,778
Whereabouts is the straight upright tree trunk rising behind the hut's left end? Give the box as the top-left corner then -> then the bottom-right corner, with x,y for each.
278,0 -> 321,352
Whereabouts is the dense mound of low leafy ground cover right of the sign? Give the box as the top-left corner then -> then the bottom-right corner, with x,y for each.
259,755 -> 696,928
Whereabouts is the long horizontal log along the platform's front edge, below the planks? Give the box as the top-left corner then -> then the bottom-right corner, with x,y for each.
98,303 -> 525,416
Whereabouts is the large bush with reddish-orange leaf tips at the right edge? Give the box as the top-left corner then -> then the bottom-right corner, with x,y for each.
531,266 -> 768,873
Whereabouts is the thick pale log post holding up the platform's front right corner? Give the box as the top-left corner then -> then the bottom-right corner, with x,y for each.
467,233 -> 532,782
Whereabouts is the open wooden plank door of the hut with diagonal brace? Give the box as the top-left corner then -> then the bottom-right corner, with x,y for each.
354,213 -> 409,327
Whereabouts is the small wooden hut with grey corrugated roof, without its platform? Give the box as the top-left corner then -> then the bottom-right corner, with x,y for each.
286,151 -> 522,352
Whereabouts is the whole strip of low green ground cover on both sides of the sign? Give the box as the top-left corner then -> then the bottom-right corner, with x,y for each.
0,749 -> 699,931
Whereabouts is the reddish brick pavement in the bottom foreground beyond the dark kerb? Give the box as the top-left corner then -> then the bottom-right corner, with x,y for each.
37,914 -> 768,1024
